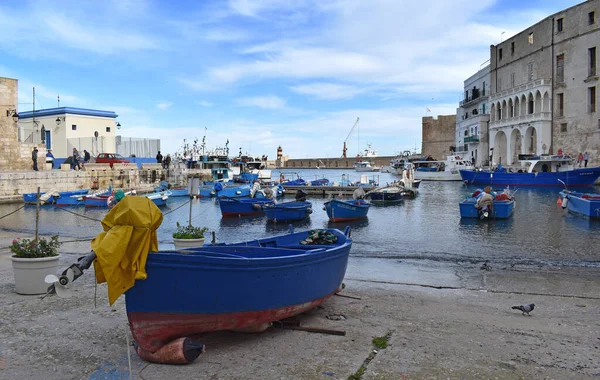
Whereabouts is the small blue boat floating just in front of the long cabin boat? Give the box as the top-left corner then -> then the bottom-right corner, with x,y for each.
459,189 -> 515,219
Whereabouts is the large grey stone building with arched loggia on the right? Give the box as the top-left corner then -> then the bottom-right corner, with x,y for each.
489,0 -> 600,165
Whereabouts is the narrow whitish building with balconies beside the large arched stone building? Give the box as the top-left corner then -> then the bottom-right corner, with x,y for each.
458,65 -> 490,167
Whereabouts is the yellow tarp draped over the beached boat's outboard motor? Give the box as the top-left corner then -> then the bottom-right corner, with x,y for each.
92,196 -> 163,305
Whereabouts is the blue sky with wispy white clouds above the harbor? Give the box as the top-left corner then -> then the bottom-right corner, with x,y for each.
0,0 -> 581,159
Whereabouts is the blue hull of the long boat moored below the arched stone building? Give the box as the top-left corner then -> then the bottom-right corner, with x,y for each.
460,167 -> 600,187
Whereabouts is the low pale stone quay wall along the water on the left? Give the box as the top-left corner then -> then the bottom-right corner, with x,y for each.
0,166 -> 211,203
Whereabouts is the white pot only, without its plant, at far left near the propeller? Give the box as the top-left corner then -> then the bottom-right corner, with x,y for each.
10,255 -> 60,294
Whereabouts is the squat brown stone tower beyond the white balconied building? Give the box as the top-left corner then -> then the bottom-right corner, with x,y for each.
421,115 -> 456,160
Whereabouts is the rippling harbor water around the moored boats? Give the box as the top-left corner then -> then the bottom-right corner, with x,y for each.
0,169 -> 600,266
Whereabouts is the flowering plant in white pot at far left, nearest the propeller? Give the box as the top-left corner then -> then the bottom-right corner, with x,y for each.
9,235 -> 61,294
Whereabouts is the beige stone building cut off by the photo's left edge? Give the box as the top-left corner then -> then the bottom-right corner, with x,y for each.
0,77 -> 32,171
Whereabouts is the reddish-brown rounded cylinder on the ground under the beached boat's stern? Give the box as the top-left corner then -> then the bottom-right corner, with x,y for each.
136,338 -> 206,364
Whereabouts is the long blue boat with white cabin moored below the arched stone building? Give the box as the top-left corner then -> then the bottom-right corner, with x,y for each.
460,155 -> 600,186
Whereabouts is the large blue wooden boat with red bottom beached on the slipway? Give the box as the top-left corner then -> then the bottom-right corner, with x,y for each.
125,228 -> 352,352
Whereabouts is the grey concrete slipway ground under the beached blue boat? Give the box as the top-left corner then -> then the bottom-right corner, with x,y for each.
0,232 -> 600,380
